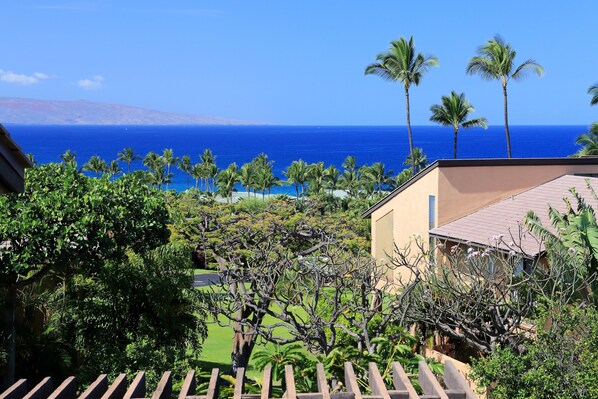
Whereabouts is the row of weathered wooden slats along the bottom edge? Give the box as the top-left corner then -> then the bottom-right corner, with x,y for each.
0,361 -> 478,399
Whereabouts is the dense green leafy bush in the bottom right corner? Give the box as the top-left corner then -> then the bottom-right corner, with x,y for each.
473,306 -> 598,399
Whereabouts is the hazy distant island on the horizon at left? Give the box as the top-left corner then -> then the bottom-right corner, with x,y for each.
0,97 -> 261,125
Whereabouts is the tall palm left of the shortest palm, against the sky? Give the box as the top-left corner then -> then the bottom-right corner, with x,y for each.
365,36 -> 438,166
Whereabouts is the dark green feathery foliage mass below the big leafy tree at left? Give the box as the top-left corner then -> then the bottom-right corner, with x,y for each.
46,243 -> 207,382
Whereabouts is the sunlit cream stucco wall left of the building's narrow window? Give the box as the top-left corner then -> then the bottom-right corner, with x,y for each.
371,169 -> 438,282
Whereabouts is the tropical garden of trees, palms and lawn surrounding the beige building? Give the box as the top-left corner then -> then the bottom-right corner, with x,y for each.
0,36 -> 598,398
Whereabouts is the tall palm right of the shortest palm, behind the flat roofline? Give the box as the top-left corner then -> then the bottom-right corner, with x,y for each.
467,35 -> 544,158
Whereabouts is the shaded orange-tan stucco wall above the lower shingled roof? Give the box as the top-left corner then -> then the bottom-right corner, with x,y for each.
438,163 -> 598,226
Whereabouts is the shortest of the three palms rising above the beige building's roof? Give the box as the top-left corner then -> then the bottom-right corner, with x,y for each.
430,91 -> 488,159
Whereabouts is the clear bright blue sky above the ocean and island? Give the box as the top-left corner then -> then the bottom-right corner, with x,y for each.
0,0 -> 598,125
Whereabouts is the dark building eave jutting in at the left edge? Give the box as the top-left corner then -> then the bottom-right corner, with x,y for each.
0,125 -> 32,194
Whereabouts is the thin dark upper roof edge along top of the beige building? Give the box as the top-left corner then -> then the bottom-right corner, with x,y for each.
361,157 -> 598,218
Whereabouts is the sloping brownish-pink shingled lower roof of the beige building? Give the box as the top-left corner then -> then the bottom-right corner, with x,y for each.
430,175 -> 598,257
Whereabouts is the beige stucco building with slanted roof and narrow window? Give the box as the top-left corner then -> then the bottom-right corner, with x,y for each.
363,158 -> 598,280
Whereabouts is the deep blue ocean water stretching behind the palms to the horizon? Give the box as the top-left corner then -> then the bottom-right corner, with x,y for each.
5,125 -> 587,192
